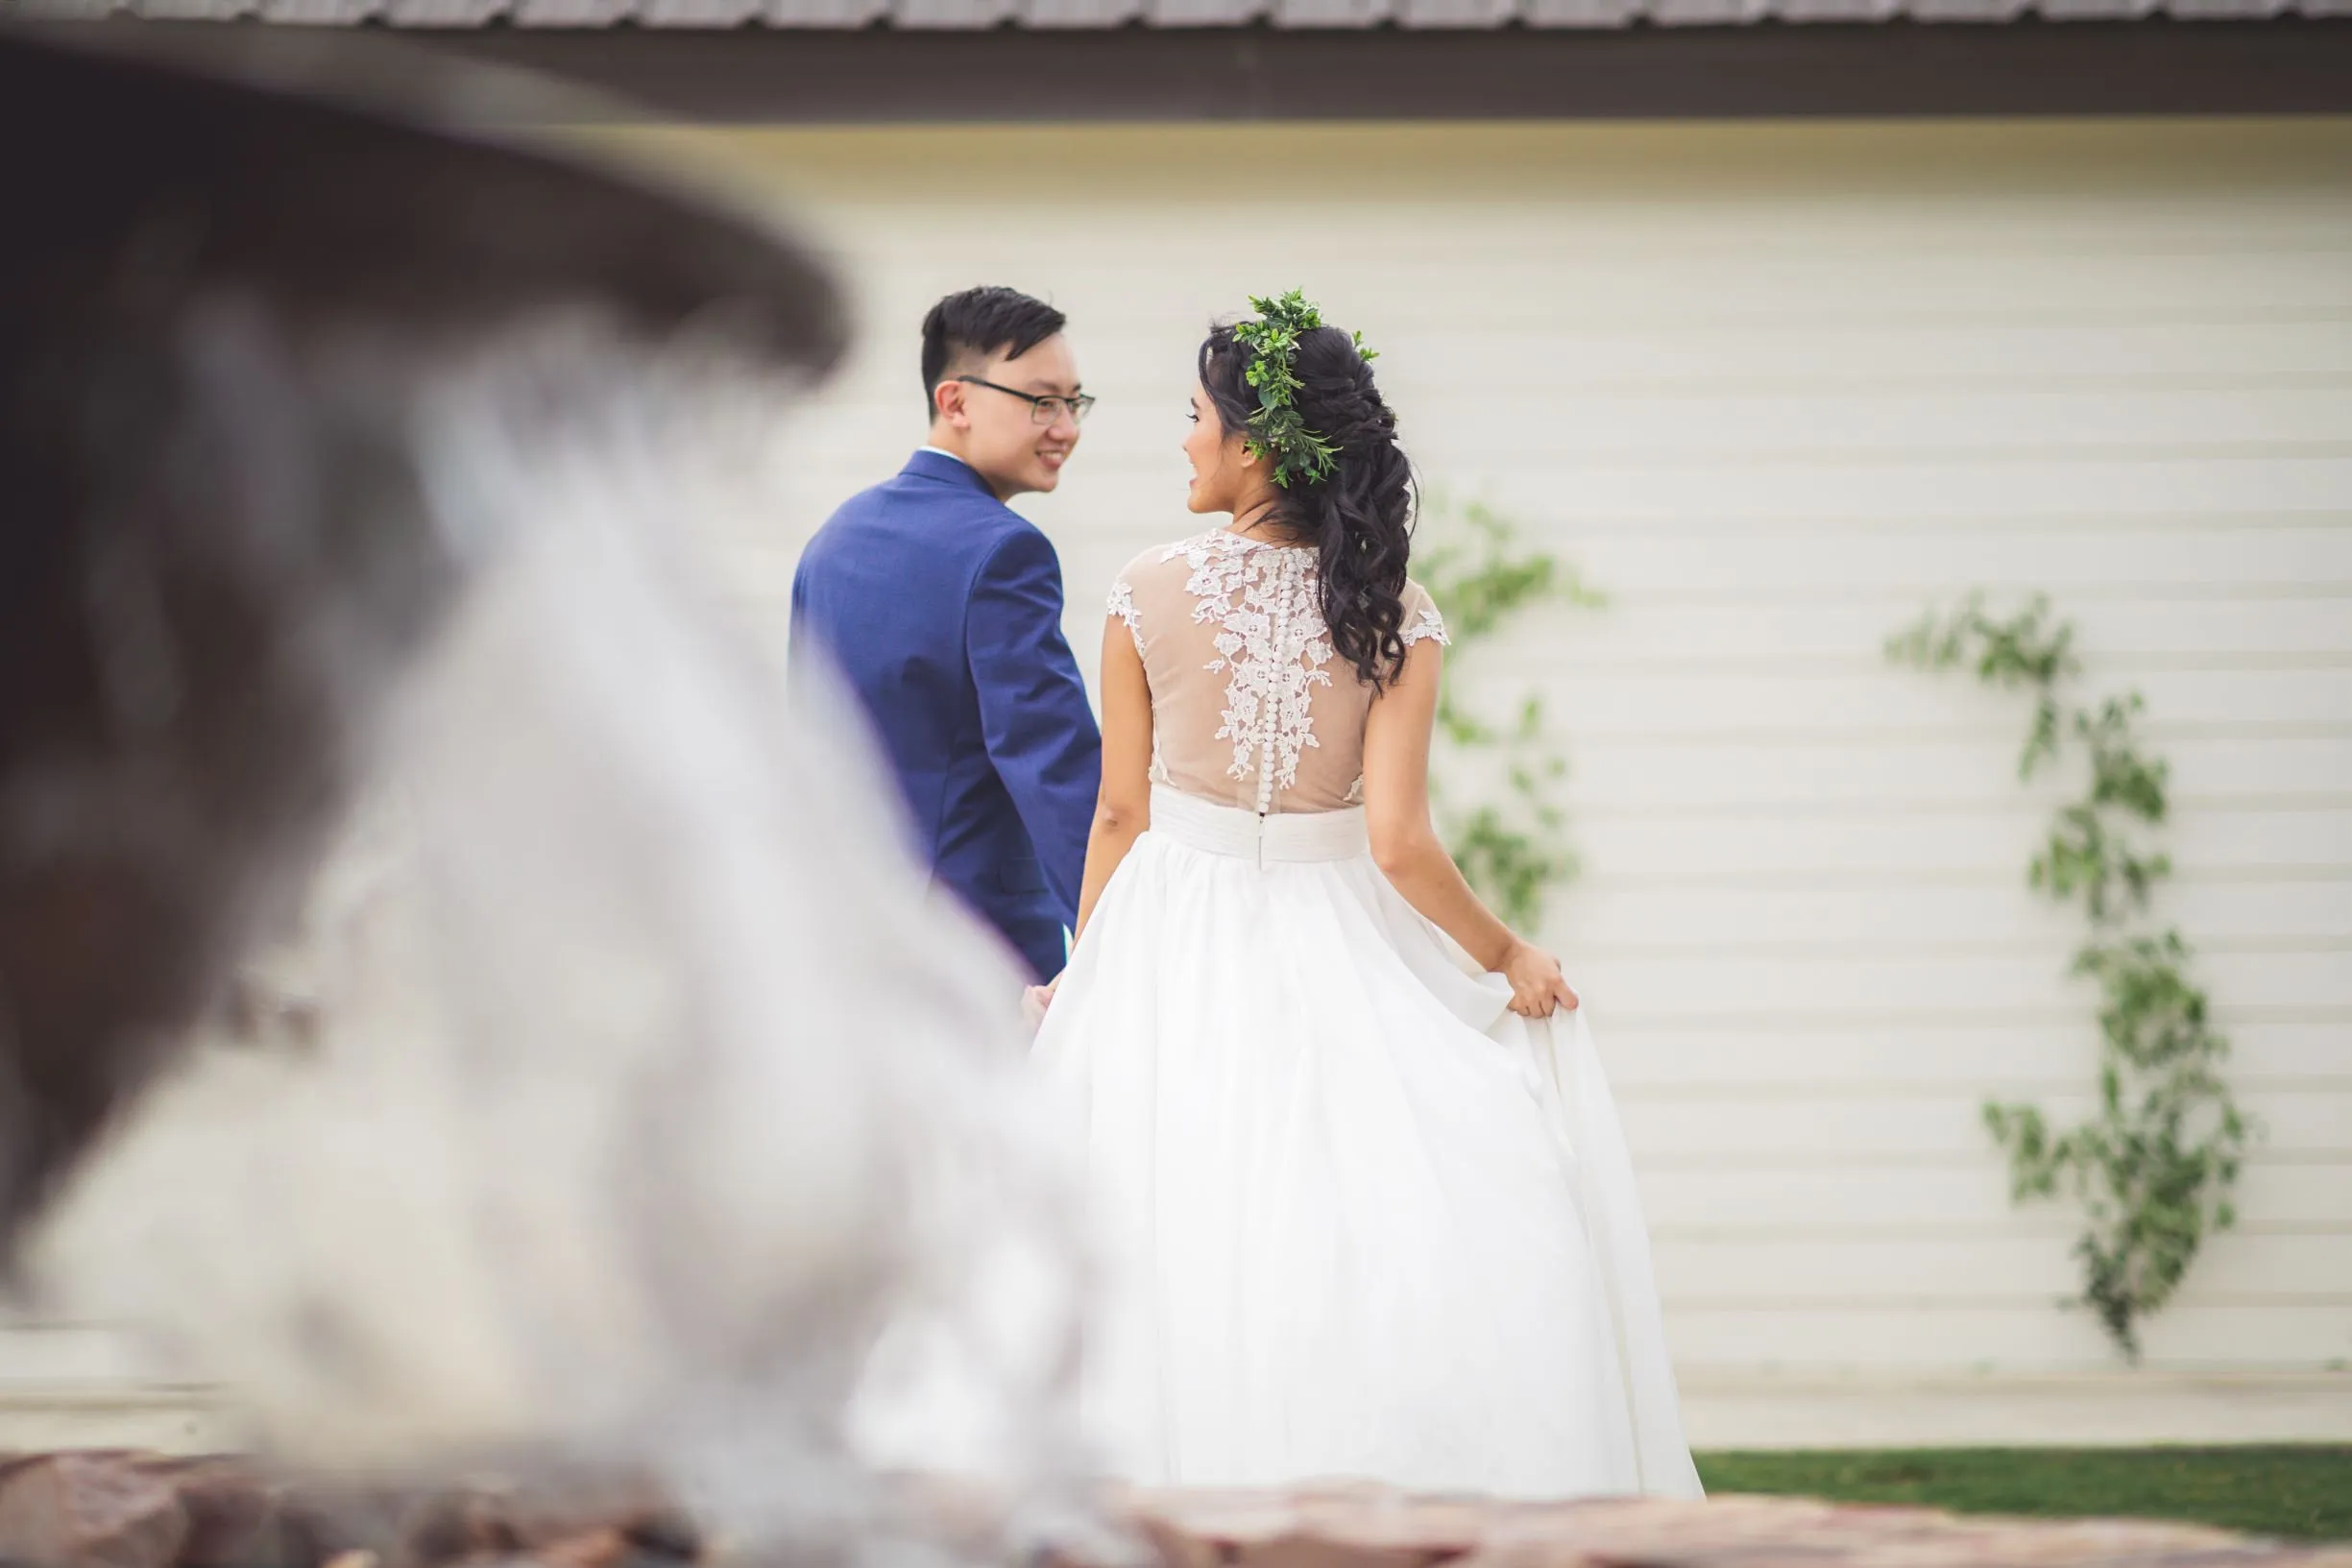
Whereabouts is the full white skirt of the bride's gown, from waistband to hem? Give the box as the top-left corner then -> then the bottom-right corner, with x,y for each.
1035,790 -> 1701,1498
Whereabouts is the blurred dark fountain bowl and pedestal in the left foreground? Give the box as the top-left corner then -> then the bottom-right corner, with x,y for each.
0,28 -> 842,1267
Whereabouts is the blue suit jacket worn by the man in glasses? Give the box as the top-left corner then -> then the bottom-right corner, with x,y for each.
792,451 -> 1103,977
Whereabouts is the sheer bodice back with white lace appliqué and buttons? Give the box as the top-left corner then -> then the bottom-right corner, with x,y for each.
1110,529 -> 1446,813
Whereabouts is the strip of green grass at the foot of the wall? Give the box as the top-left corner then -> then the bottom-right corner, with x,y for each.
1698,1446 -> 2352,1540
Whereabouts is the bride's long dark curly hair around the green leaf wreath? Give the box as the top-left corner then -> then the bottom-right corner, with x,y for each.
1200,326 -> 1416,688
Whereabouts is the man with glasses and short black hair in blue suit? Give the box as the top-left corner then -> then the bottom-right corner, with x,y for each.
790,289 -> 1103,980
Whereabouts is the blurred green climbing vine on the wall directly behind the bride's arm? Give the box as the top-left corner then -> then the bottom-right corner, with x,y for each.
1414,503 -> 1607,929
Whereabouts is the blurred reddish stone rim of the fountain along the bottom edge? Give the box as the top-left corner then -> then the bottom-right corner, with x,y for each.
0,1453 -> 2352,1568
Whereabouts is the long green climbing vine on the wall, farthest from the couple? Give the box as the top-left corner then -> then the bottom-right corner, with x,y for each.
1886,594 -> 2256,1362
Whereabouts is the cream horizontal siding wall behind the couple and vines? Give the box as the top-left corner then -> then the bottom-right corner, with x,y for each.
633,119 -> 2352,1370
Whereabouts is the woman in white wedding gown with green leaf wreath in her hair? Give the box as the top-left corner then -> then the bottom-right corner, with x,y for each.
1032,292 -> 1701,1498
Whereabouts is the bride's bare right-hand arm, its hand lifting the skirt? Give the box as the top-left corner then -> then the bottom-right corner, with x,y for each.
1364,637 -> 1576,1018
